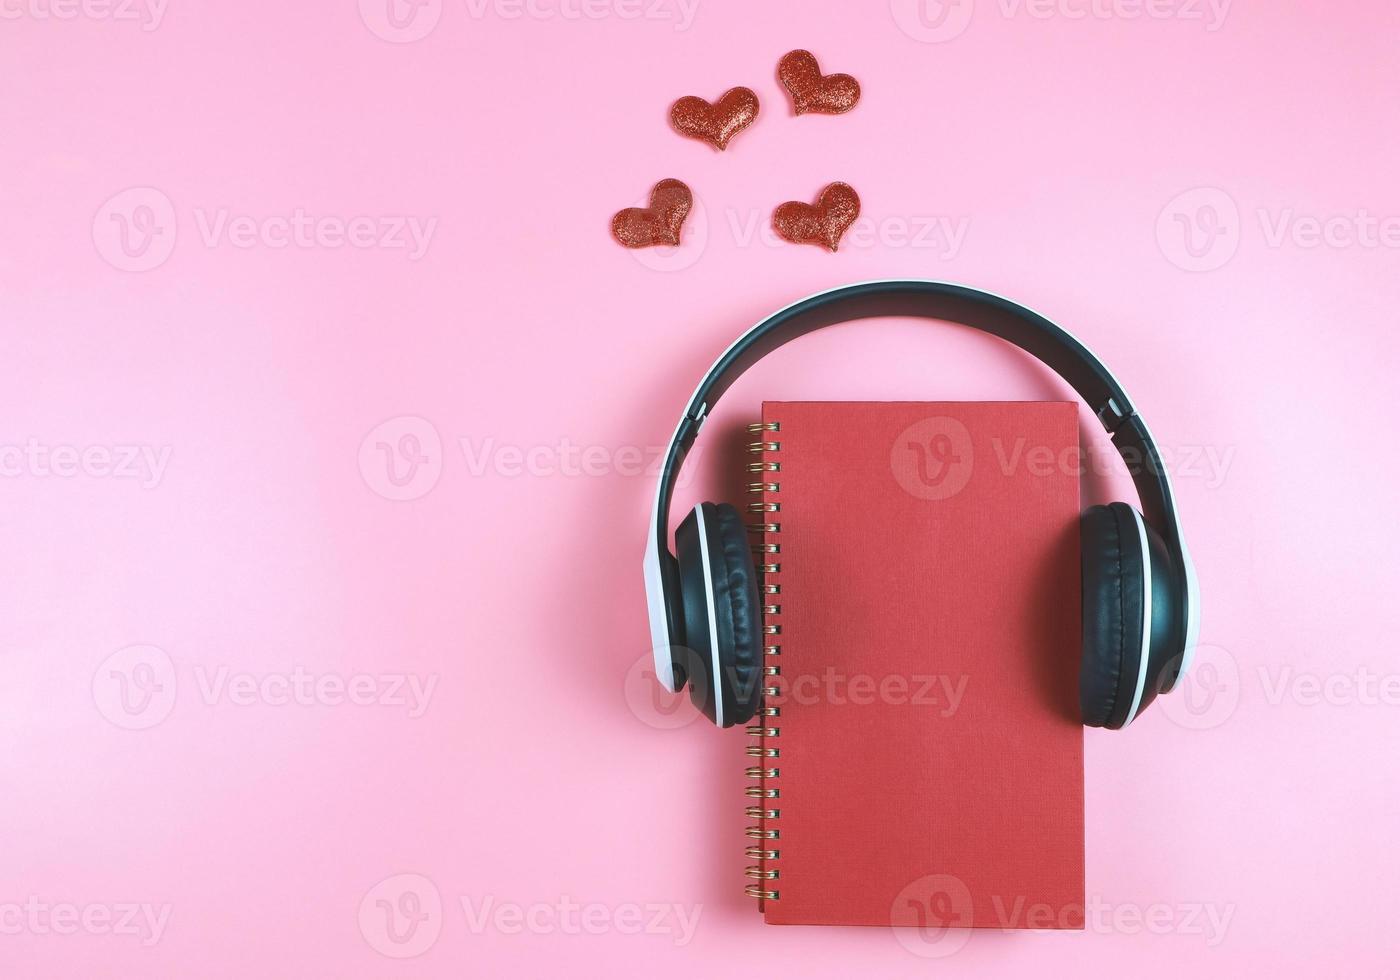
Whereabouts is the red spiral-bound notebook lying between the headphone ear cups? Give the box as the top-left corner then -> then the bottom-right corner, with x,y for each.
748,402 -> 1084,928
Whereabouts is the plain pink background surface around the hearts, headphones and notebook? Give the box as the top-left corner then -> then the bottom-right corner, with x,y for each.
0,0 -> 1400,977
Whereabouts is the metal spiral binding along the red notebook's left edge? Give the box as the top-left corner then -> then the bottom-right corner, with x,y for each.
743,421 -> 783,907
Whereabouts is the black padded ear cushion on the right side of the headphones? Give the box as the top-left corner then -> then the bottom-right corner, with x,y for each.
1079,503 -> 1148,728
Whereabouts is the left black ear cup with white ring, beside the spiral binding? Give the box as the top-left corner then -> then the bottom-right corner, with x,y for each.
676,503 -> 763,728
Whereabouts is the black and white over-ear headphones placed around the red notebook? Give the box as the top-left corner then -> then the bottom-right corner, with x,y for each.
643,280 -> 1200,728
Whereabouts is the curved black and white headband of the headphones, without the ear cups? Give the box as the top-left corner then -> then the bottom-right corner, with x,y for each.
645,279 -> 1196,690
